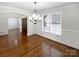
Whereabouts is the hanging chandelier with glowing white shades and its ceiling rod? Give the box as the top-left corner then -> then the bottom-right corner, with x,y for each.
29,2 -> 41,24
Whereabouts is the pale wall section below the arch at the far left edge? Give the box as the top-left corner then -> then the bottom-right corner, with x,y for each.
0,15 -> 8,35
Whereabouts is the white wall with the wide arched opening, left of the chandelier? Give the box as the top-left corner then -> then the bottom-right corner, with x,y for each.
0,5 -> 34,35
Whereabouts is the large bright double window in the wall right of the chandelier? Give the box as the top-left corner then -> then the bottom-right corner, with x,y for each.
42,14 -> 62,35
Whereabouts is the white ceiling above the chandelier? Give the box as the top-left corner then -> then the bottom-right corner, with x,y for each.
0,2 -> 69,11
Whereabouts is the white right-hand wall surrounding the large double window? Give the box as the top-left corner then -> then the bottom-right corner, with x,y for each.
36,3 -> 79,49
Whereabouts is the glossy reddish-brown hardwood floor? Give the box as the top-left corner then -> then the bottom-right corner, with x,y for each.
0,29 -> 79,57
